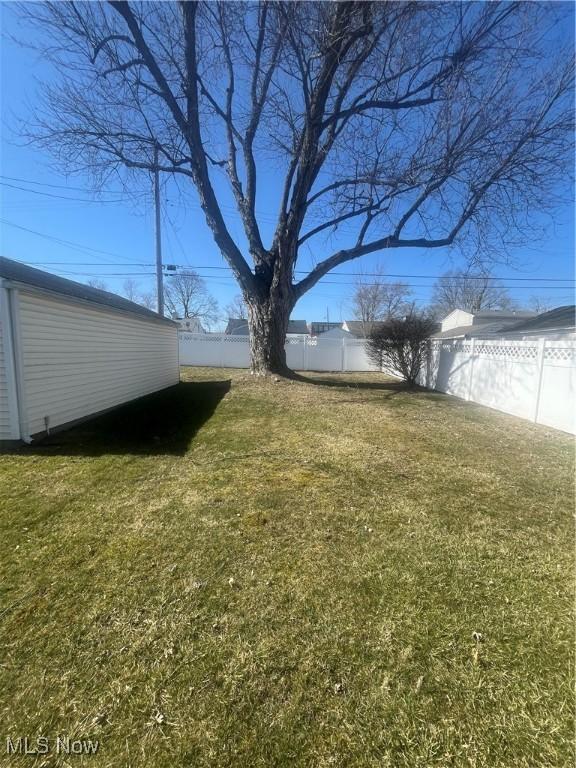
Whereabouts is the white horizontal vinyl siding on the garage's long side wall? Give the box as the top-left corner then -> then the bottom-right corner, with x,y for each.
18,289 -> 179,435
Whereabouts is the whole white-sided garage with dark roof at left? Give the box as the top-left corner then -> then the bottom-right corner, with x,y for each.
0,258 -> 180,442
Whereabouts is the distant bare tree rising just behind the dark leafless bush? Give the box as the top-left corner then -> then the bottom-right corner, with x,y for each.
352,267 -> 412,338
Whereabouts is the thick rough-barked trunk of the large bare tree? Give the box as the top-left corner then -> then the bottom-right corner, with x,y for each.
246,294 -> 292,376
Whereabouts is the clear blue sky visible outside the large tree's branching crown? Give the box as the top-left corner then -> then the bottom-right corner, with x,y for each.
0,3 -> 574,321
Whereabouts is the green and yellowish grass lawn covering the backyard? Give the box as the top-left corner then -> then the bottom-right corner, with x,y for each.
0,368 -> 574,768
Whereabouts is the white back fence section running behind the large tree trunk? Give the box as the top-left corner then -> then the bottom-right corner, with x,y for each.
179,331 -> 378,371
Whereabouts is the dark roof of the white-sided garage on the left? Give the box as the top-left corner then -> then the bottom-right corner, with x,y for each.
0,256 -> 174,325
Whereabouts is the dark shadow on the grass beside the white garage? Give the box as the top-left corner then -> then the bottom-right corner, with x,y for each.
15,380 -> 230,456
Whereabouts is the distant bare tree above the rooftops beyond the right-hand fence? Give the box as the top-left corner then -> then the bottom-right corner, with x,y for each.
432,270 -> 515,318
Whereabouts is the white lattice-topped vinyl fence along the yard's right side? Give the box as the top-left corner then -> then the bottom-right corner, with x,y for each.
419,339 -> 576,433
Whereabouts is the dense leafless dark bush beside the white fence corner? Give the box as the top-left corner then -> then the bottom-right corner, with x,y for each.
366,312 -> 436,386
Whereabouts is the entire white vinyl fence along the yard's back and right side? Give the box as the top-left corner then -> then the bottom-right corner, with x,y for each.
179,331 -> 576,433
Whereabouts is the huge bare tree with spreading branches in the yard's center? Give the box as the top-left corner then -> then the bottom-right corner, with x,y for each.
16,1 -> 573,373
